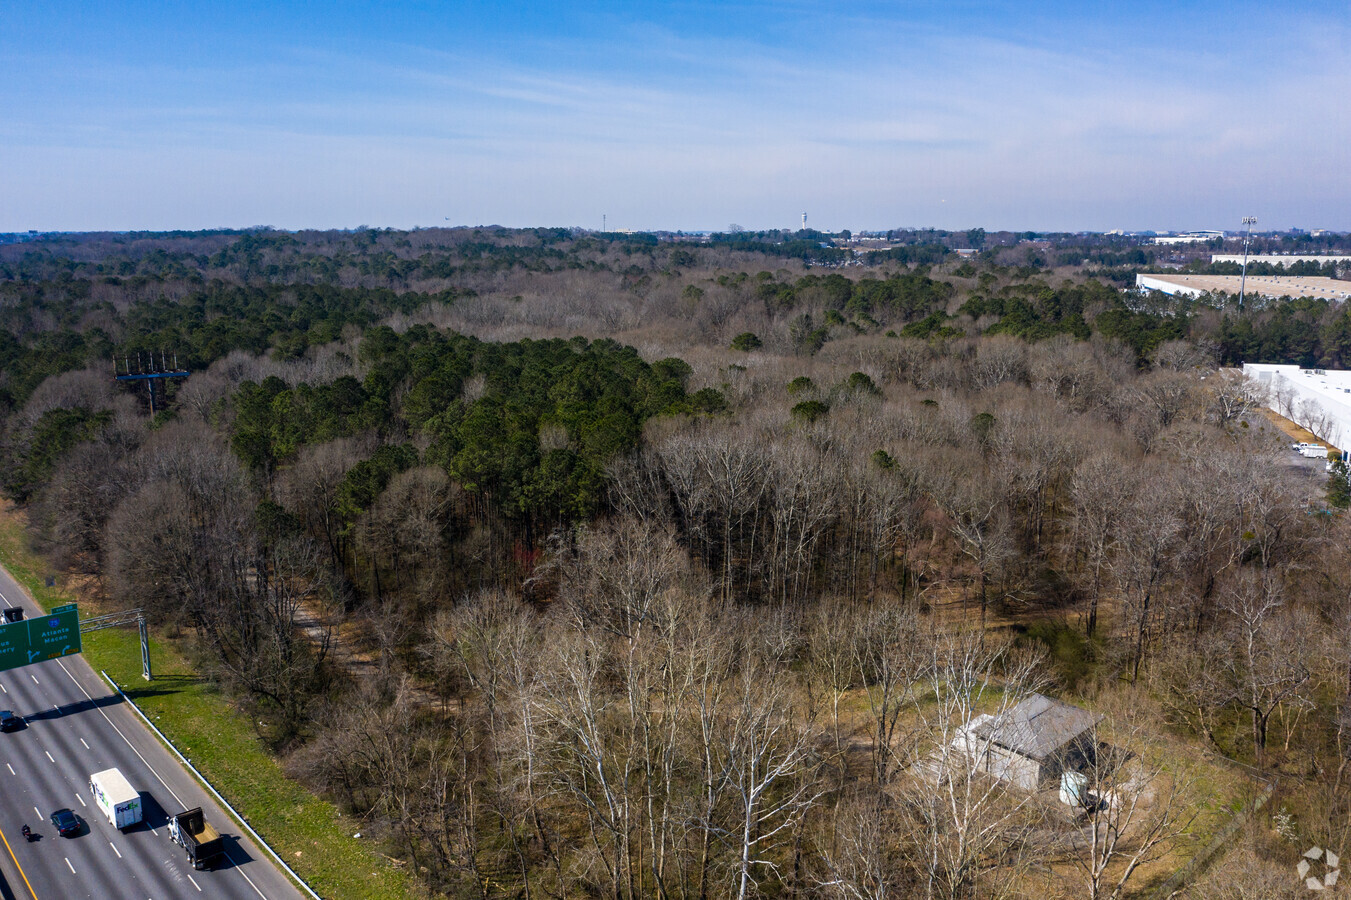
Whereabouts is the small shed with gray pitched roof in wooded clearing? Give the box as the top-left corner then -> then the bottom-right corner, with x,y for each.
959,693 -> 1102,791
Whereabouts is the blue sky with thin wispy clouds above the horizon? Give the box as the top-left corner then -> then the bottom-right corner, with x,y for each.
0,0 -> 1351,231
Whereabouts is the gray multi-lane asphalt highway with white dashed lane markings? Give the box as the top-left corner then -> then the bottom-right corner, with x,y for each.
0,568 -> 303,900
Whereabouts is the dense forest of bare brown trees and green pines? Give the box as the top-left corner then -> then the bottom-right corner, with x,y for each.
0,228 -> 1351,900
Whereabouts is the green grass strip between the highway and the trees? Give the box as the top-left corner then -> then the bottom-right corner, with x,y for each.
0,509 -> 415,900
